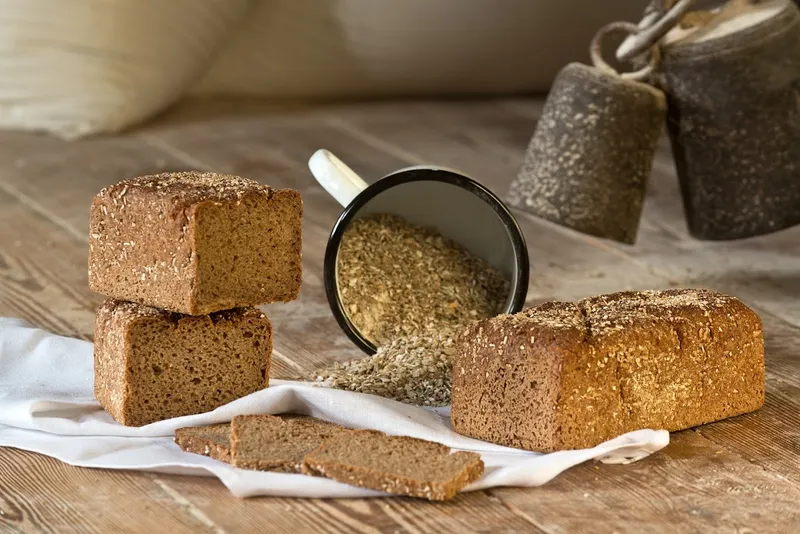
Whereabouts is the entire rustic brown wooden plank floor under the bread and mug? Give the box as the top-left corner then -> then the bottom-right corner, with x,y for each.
0,99 -> 800,534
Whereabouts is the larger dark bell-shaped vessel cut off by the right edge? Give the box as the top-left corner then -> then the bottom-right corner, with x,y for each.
657,0 -> 800,240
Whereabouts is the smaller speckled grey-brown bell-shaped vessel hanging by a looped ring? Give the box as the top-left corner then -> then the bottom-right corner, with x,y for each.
509,22 -> 667,243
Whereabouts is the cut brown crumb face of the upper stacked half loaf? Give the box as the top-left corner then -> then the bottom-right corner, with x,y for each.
194,189 -> 303,312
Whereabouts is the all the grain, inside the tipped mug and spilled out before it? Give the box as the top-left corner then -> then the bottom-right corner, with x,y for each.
314,214 -> 510,406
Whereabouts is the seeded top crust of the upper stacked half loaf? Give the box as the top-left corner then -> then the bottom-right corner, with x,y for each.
98,171 -> 273,210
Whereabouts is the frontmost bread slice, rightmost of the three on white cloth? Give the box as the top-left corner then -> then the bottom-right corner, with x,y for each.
303,430 -> 483,501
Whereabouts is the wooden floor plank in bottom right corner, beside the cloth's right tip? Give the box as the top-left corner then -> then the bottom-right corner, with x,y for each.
491,431 -> 800,534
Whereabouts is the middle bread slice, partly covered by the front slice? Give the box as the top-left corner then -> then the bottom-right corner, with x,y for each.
231,414 -> 350,473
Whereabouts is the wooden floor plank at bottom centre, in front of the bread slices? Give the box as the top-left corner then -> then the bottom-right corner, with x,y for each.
161,477 -> 542,534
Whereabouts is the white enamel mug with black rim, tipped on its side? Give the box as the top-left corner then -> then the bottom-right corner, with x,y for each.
308,149 -> 530,354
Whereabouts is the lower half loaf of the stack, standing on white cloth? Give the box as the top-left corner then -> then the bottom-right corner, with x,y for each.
94,299 -> 272,426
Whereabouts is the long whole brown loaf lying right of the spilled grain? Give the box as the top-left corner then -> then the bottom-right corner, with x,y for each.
452,289 -> 765,452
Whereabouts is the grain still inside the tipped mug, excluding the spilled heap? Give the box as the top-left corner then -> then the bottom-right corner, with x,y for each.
336,214 -> 510,345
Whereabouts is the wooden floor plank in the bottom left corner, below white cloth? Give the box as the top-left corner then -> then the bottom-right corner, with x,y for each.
0,448 -> 219,534
